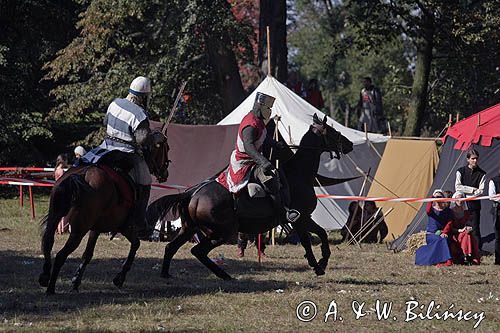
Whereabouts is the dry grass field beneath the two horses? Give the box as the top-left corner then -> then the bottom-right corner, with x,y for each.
0,196 -> 500,332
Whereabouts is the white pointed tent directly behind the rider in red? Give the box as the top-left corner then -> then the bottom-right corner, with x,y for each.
218,76 -> 388,230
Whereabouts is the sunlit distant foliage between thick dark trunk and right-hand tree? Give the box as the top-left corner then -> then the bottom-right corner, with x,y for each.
289,0 -> 411,130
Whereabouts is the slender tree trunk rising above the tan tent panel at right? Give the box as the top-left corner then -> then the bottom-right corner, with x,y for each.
403,31 -> 434,136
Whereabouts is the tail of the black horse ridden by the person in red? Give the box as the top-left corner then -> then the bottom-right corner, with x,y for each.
146,189 -> 195,225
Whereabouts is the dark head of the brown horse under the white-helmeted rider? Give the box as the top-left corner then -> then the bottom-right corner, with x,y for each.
145,129 -> 170,183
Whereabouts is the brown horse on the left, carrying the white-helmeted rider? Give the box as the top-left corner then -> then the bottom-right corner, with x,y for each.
38,131 -> 170,294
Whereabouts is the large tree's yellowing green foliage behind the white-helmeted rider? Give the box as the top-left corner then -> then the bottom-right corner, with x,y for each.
46,0 -> 252,130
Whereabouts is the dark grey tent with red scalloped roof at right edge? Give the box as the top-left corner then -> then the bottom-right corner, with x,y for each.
391,104 -> 500,251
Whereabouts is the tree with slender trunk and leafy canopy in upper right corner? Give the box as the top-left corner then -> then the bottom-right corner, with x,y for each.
346,0 -> 498,135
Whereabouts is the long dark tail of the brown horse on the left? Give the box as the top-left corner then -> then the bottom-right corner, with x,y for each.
40,174 -> 93,253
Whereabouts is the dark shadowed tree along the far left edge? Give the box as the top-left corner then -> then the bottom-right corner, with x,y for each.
0,0 -> 80,164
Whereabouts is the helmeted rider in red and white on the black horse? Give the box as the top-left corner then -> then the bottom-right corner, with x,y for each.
217,92 -> 300,222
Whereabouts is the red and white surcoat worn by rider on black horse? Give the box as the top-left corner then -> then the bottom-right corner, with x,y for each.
217,112 -> 267,193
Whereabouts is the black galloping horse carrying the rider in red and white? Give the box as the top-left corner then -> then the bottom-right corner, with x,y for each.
148,115 -> 353,280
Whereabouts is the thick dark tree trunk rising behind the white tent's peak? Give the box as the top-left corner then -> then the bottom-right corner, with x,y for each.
259,0 -> 288,83
